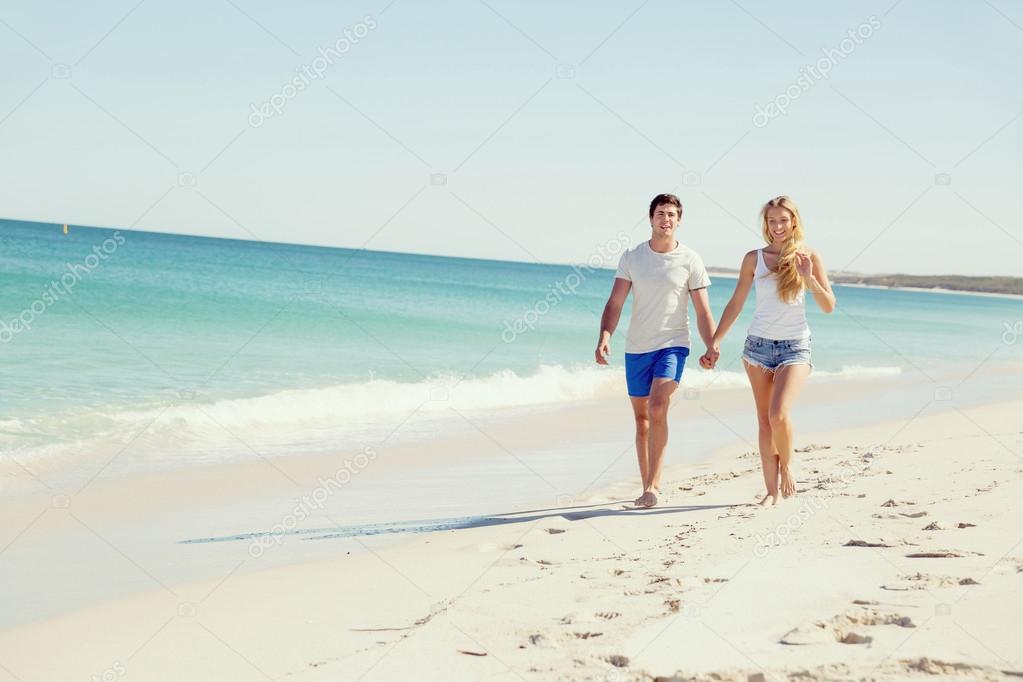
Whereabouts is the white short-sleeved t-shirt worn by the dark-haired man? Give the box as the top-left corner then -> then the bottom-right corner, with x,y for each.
615,241 -> 710,353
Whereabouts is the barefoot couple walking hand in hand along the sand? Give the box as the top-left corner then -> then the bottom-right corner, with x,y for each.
595,194 -> 836,507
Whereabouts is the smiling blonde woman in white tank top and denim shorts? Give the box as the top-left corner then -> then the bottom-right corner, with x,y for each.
700,196 -> 835,504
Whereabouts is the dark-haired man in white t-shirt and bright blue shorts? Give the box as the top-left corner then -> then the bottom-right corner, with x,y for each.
595,194 -> 715,507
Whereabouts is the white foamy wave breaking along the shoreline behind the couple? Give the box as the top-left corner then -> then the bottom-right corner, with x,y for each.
0,365 -> 901,472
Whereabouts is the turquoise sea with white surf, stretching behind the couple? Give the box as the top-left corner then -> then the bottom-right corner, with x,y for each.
0,221 -> 1023,474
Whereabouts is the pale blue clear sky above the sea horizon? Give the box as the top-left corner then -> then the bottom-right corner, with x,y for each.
0,0 -> 1023,275
